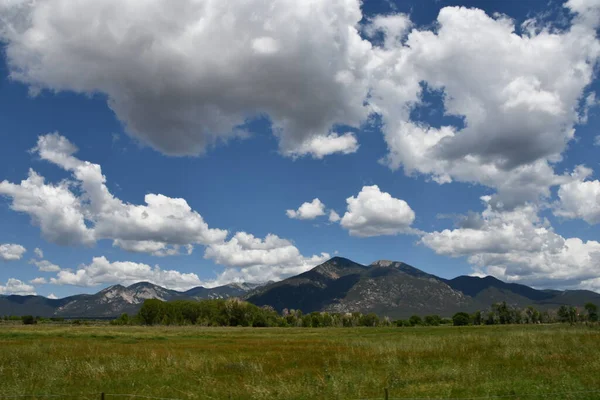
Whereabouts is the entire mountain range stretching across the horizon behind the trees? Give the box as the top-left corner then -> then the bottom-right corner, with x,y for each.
0,257 -> 600,318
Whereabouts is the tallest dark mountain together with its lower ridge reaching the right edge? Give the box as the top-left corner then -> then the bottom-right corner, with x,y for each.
247,257 -> 600,318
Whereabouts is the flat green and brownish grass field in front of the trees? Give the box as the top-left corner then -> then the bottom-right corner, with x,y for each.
0,325 -> 600,400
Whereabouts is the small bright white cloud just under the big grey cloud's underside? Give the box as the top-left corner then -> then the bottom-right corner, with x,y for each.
286,132 -> 360,159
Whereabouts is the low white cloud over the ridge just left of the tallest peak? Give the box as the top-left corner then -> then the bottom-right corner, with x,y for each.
204,232 -> 330,285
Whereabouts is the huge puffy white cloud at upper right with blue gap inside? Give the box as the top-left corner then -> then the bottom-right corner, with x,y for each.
370,2 -> 600,209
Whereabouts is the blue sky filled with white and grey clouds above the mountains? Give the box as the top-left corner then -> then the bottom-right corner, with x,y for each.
0,0 -> 600,297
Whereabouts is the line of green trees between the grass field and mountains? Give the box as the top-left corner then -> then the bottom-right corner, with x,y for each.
111,298 -> 598,328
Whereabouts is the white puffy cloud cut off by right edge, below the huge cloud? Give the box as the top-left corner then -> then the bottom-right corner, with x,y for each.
554,166 -> 600,224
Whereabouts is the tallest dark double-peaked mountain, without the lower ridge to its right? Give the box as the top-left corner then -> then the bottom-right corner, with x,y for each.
248,257 -> 472,318
